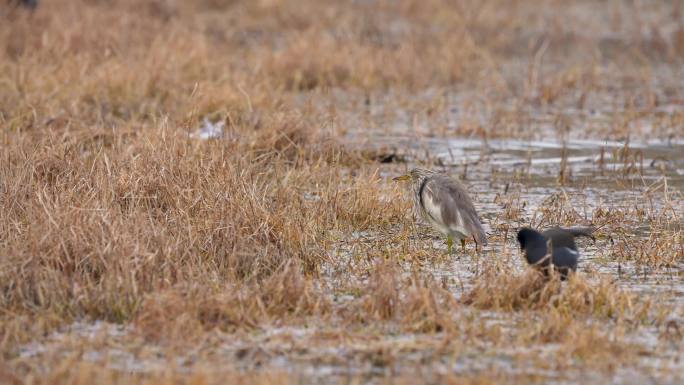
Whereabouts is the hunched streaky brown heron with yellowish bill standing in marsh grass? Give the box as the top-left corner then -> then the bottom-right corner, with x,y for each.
393,168 -> 487,254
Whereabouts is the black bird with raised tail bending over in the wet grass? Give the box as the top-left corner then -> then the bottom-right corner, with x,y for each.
518,227 -> 594,280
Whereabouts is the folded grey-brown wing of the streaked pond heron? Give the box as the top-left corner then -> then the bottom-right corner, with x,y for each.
421,176 -> 487,245
